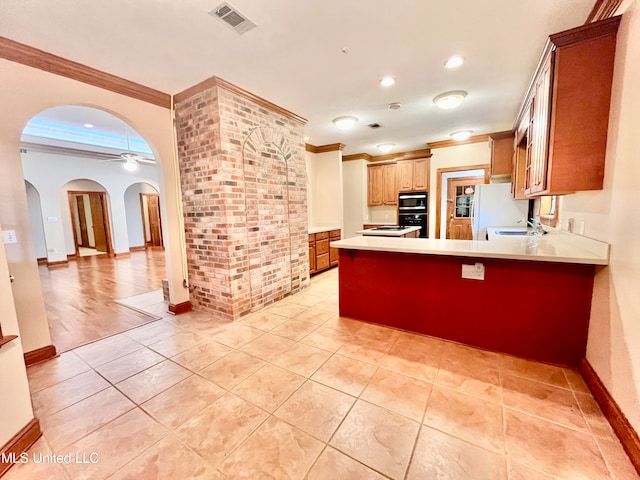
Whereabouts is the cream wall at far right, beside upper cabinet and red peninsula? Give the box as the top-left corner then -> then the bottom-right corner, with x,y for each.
560,0 -> 640,432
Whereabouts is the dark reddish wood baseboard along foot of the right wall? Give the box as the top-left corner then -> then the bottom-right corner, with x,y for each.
579,358 -> 640,474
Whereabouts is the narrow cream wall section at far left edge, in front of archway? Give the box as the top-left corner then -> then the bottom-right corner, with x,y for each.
0,225 -> 33,445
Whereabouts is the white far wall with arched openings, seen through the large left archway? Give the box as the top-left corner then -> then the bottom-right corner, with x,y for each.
22,151 -> 158,262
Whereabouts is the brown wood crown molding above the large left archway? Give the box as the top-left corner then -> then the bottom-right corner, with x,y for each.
0,37 -> 171,108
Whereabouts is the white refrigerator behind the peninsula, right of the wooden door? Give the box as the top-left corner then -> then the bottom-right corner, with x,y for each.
472,183 -> 529,240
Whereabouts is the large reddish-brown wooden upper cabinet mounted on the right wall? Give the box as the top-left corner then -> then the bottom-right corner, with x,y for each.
512,17 -> 620,198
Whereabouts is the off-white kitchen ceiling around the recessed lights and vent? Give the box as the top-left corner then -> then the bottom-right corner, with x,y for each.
0,0 -> 594,155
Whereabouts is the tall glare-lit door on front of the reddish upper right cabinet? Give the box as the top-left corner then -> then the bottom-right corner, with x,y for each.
527,55 -> 553,194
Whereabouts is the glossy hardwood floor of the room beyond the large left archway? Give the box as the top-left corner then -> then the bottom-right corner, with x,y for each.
39,249 -> 166,353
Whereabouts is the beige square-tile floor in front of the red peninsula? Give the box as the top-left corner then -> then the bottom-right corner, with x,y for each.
5,270 -> 638,480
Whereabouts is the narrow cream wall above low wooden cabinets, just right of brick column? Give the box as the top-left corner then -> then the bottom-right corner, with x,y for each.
305,150 -> 343,227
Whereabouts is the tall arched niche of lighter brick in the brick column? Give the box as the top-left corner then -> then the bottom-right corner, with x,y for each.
242,126 -> 296,310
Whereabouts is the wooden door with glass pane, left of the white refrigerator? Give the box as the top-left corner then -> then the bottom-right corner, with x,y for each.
447,177 -> 484,240
